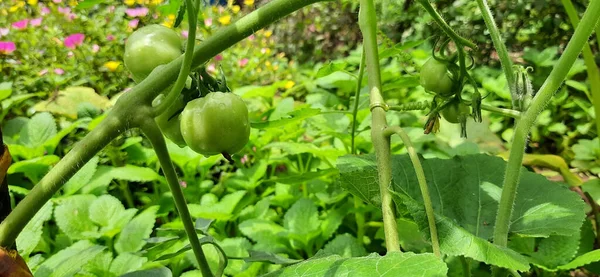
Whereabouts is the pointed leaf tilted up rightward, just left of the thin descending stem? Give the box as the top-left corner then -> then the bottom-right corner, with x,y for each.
115,206 -> 158,253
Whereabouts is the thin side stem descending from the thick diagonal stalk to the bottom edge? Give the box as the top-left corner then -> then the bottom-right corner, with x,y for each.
140,115 -> 213,277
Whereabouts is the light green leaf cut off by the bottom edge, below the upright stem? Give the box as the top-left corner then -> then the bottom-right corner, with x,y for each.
265,252 -> 448,277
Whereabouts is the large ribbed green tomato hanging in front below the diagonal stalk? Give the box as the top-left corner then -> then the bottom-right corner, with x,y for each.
180,92 -> 250,156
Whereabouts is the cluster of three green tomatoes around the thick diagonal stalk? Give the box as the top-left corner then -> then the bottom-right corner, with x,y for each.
125,25 -> 250,157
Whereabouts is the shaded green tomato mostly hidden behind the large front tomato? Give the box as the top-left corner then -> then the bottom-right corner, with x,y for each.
152,94 -> 185,147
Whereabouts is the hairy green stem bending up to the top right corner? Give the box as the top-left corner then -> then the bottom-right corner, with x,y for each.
494,1 -> 600,246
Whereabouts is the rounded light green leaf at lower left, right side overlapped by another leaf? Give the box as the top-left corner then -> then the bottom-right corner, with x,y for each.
54,194 -> 100,240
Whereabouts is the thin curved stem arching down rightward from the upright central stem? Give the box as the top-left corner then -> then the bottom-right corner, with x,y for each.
383,126 -> 442,257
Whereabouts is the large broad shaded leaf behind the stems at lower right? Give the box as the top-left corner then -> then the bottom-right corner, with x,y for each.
338,155 -> 585,270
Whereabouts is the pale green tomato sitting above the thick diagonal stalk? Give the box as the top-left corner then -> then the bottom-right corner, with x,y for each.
124,24 -> 181,83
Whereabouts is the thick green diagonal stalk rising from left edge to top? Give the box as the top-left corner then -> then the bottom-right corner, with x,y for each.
0,0 -> 321,246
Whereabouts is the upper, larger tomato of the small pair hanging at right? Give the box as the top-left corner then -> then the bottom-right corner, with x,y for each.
420,58 -> 454,97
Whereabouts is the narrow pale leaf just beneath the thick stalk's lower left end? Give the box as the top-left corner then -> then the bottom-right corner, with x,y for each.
16,199 -> 53,257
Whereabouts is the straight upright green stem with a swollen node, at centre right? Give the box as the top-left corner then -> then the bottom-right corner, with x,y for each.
358,0 -> 400,251
